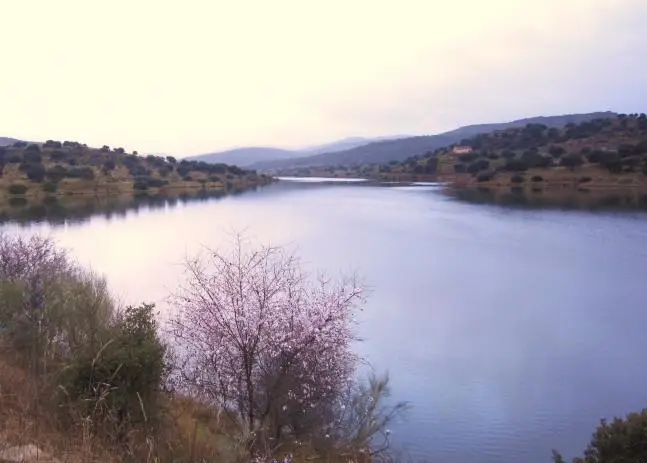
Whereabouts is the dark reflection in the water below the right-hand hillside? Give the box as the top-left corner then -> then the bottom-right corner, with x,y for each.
444,187 -> 647,211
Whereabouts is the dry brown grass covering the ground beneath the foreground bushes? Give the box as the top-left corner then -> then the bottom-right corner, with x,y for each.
0,355 -> 386,463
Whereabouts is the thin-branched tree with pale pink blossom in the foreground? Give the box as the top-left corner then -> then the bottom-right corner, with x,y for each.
171,236 -> 363,446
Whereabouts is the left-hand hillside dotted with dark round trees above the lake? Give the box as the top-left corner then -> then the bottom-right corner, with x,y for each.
0,140 -> 270,199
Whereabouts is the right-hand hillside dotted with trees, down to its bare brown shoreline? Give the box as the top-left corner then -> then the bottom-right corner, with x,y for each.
319,114 -> 647,189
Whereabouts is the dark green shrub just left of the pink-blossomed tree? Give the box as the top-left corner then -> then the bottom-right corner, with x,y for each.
59,304 -> 167,440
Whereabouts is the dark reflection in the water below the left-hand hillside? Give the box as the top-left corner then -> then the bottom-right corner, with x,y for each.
0,189 -> 255,225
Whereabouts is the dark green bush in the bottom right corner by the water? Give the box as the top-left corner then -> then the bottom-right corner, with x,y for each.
553,409 -> 647,463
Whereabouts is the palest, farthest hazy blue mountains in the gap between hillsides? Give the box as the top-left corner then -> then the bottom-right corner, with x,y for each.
186,135 -> 407,167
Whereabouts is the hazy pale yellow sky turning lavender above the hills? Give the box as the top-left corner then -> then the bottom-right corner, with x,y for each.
0,0 -> 647,155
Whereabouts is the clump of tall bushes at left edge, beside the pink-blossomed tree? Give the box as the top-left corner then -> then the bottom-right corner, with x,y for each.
0,235 -> 165,439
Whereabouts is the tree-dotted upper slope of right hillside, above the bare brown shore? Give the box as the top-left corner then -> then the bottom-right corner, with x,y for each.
378,113 -> 647,180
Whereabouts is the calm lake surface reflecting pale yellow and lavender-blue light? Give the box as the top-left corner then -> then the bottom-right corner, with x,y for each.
0,181 -> 647,463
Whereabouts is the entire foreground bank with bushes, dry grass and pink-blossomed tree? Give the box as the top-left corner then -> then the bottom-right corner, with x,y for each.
0,236 -> 404,462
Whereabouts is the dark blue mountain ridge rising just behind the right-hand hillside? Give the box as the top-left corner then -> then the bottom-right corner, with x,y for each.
247,111 -> 616,173
